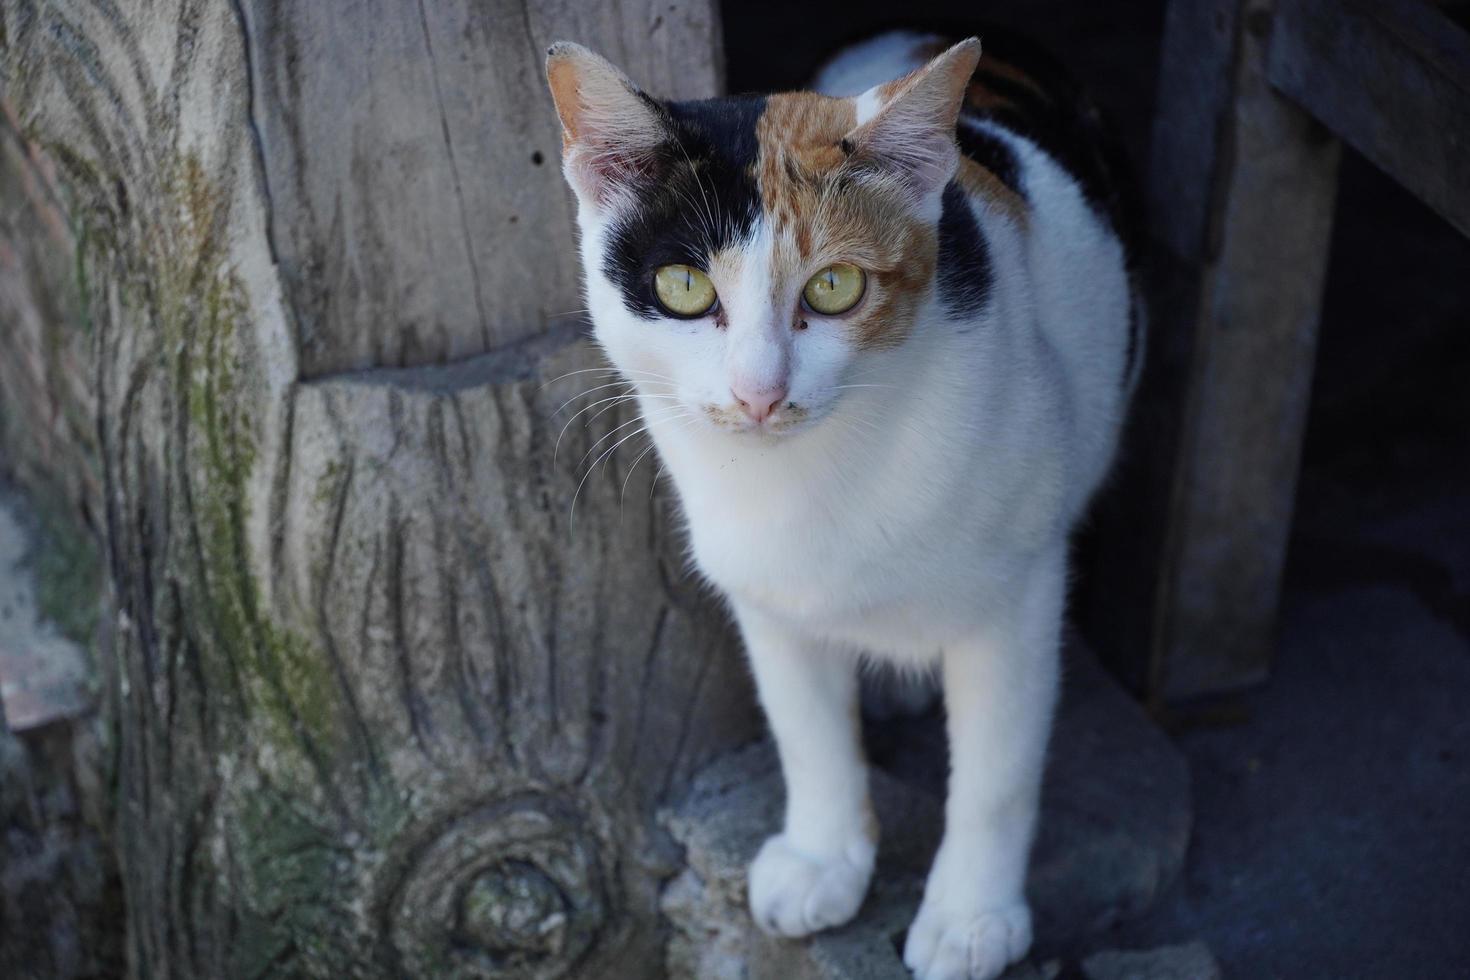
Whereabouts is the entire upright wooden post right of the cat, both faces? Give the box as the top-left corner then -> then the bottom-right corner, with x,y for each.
1089,0 -> 1339,699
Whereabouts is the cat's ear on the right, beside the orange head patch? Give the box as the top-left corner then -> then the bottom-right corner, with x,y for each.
845,37 -> 980,201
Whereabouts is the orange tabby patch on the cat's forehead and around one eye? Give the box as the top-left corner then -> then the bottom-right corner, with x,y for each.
756,93 -> 938,350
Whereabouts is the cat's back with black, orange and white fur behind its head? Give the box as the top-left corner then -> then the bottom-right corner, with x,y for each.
813,29 -> 1147,498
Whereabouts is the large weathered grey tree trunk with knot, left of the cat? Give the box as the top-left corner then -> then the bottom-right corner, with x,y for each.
0,0 -> 756,979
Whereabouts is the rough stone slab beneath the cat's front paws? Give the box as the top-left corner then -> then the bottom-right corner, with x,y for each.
663,644 -> 1191,980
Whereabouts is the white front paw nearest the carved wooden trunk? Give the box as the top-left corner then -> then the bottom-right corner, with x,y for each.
750,833 -> 875,936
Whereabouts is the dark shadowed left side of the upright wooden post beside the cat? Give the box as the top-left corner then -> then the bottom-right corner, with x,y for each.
1079,0 -> 1242,693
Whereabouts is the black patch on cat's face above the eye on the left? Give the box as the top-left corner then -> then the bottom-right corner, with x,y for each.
603,96 -> 766,320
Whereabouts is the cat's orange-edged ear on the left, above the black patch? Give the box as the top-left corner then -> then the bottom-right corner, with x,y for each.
547,41 -> 669,210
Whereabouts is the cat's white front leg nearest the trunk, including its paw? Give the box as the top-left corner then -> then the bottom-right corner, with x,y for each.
735,604 -> 878,936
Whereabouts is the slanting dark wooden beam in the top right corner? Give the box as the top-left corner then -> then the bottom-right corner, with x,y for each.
1267,0 -> 1470,235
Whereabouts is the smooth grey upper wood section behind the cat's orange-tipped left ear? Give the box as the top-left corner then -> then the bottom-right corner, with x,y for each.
241,0 -> 720,378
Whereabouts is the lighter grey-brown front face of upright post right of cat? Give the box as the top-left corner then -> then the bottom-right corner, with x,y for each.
1155,3 -> 1339,698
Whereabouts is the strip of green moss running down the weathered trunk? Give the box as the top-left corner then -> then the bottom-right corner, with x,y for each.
140,157 -> 388,977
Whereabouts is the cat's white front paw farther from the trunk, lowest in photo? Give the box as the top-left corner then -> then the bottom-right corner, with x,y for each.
904,896 -> 1030,980
